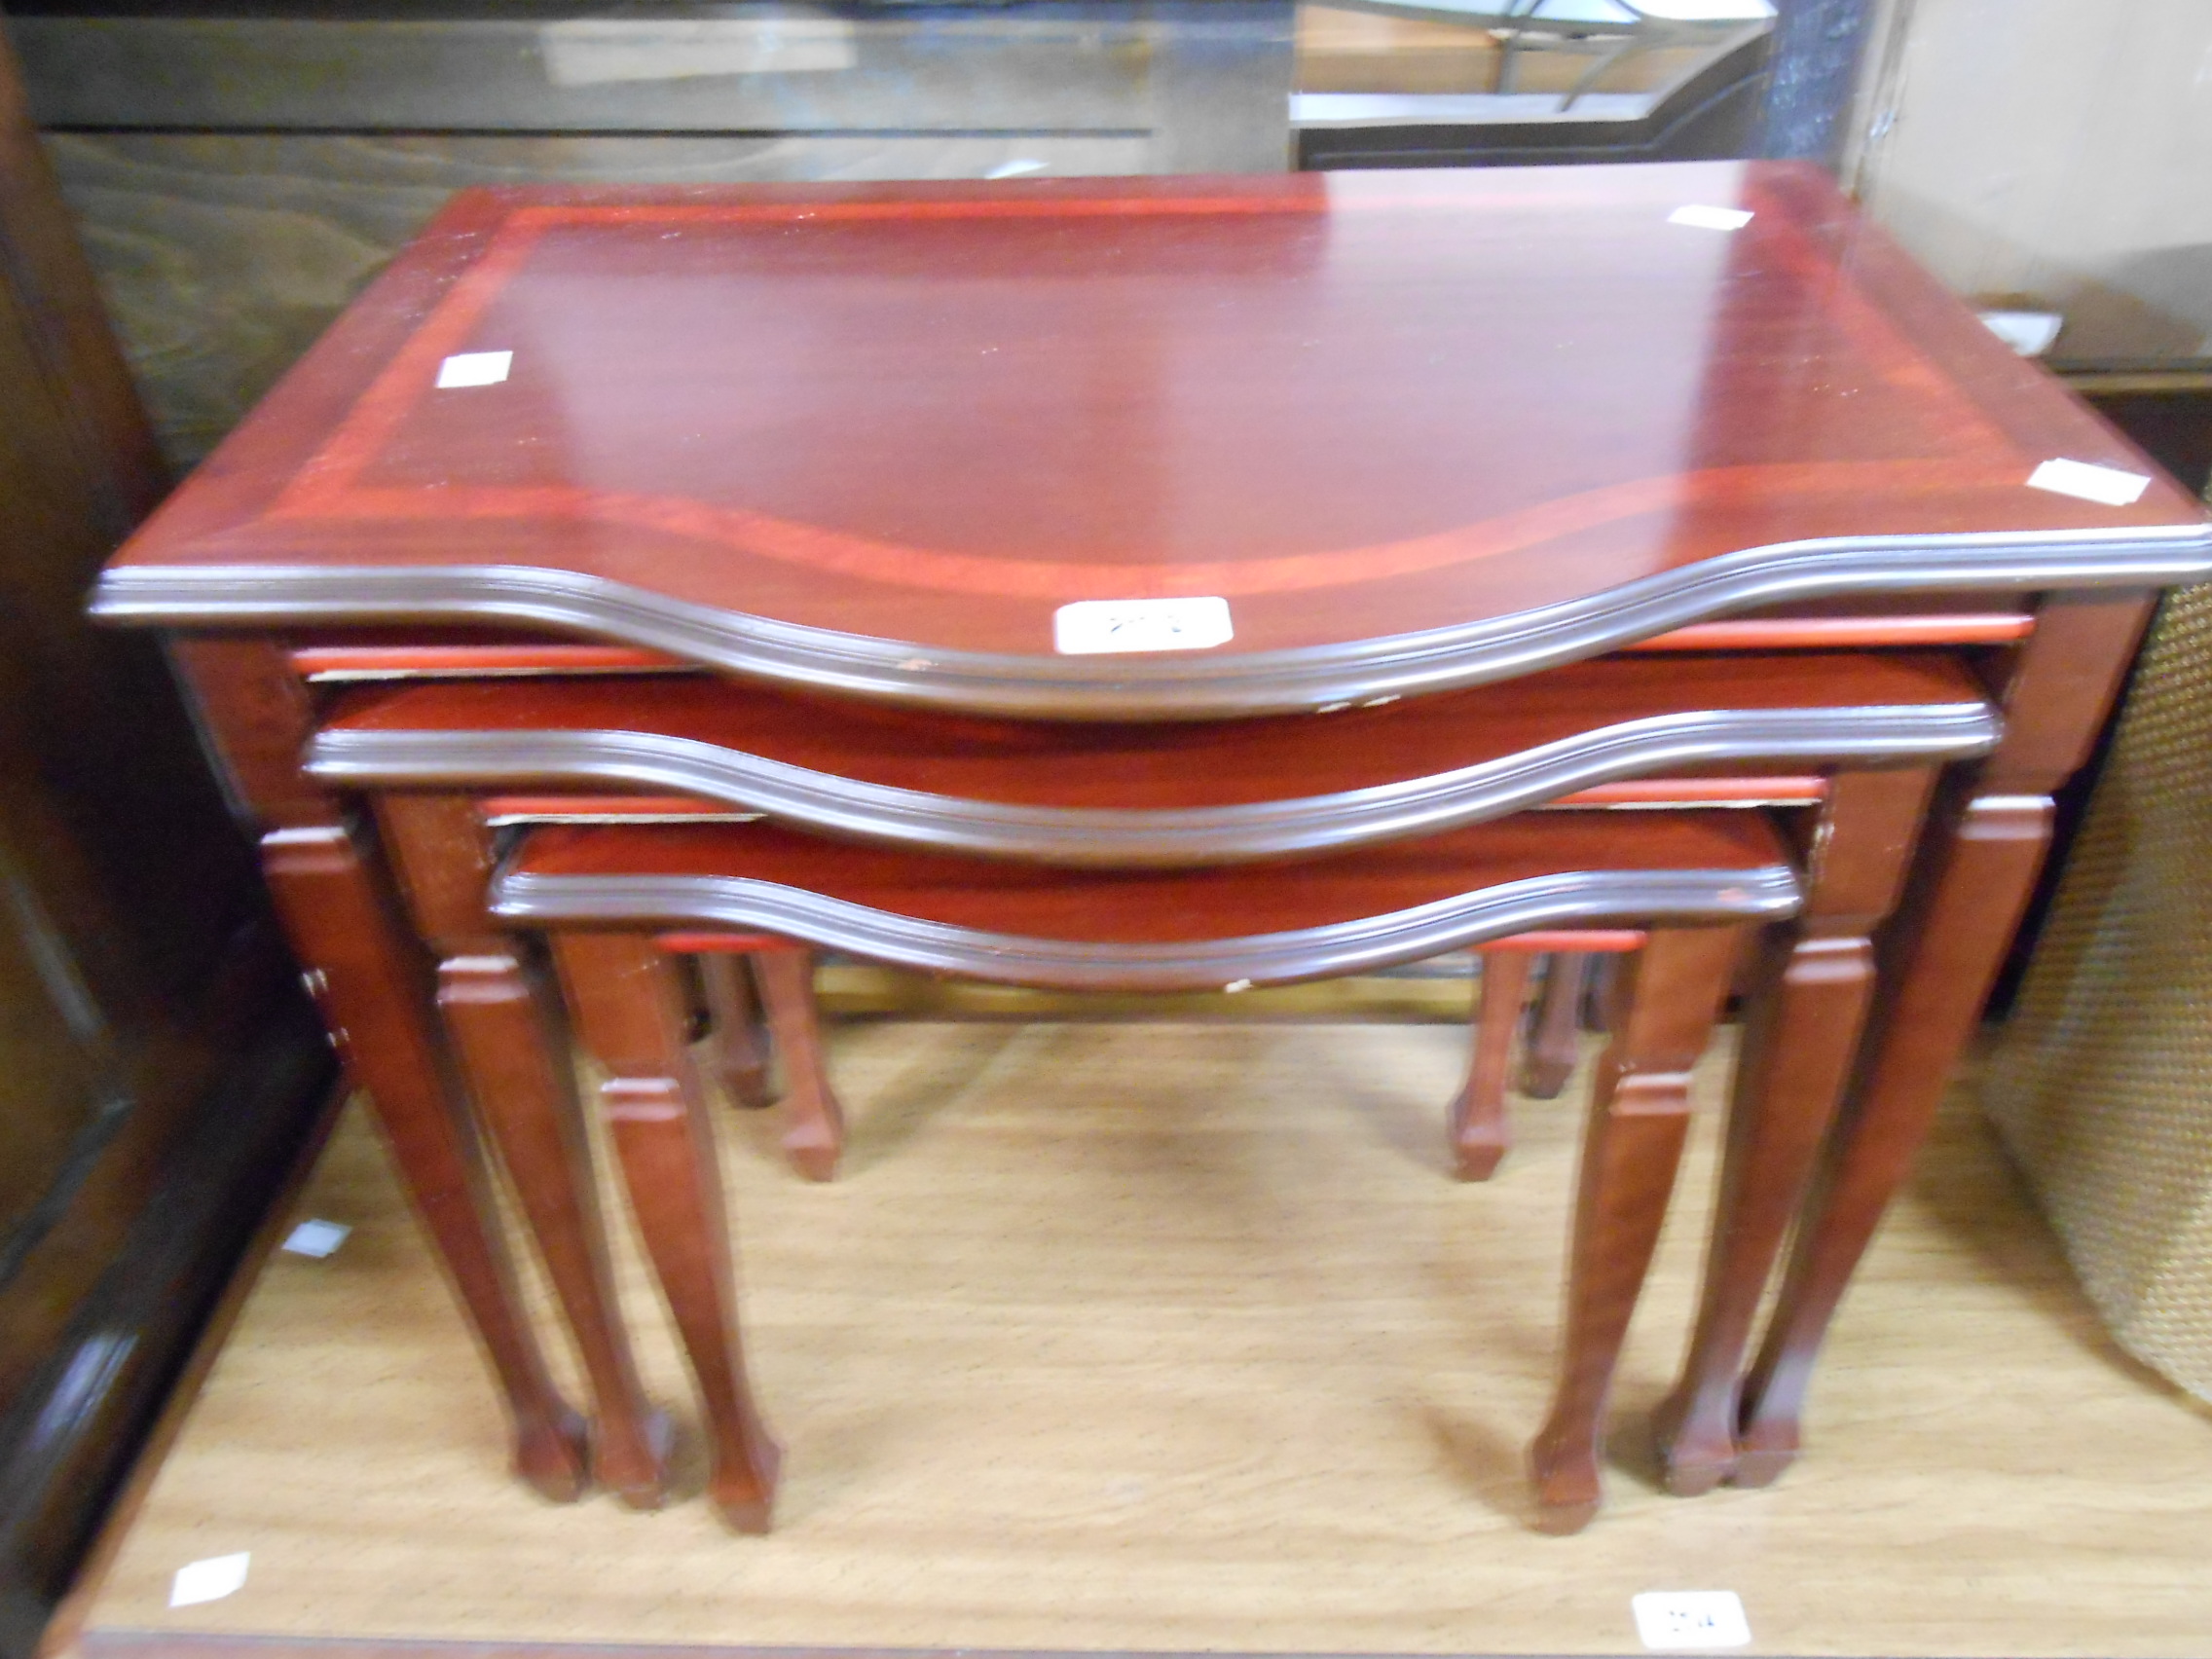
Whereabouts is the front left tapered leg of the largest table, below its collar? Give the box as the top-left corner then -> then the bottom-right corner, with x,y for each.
261,825 -> 586,1502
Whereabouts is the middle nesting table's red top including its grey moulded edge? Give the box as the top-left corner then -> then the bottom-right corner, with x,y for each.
308,652 -> 1998,865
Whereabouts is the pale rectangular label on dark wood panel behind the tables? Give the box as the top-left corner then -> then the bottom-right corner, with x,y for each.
537,16 -> 861,87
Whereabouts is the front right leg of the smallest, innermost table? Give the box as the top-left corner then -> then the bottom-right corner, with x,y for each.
1529,927 -> 1743,1532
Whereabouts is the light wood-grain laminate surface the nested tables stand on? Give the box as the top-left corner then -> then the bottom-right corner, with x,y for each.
60,1022 -> 2212,1659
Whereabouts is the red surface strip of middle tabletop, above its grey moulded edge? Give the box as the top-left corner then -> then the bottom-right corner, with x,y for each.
310,652 -> 1995,827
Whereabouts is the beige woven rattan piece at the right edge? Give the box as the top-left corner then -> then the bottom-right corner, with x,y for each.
1984,588 -> 2212,1400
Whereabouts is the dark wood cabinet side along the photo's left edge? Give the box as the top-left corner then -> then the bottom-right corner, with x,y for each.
0,25 -> 334,1659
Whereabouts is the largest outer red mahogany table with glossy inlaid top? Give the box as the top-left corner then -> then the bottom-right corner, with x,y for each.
95,164 -> 2212,1530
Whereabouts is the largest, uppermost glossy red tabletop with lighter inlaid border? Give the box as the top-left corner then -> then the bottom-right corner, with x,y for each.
95,164 -> 2212,717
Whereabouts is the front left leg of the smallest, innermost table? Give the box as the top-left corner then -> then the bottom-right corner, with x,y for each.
553,932 -> 781,1532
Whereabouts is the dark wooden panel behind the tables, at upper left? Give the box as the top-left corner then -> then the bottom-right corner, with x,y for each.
7,0 -> 1292,466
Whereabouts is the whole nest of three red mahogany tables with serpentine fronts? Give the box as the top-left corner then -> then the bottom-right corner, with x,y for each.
95,164 -> 2212,1527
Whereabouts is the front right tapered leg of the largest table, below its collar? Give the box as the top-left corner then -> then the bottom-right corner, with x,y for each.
1734,794 -> 2050,1487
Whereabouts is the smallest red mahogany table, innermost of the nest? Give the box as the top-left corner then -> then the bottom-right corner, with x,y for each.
491,812 -> 1800,1532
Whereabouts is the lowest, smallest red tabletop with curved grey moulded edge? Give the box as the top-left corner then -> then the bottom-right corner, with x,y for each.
489,812 -> 1800,991
